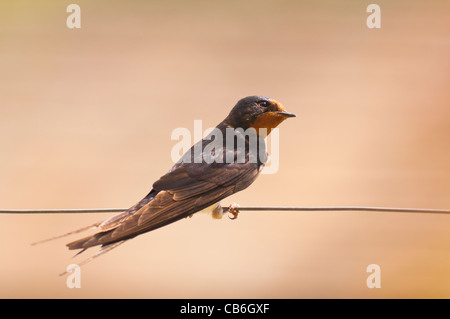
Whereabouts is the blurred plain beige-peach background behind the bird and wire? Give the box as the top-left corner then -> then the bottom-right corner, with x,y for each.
0,0 -> 450,298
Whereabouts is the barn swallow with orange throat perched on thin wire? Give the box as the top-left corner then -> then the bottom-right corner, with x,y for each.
43,96 -> 295,272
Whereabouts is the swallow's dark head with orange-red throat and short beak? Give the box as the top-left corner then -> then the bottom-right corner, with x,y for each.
226,96 -> 295,134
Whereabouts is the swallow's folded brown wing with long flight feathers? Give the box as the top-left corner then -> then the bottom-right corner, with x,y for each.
67,163 -> 259,249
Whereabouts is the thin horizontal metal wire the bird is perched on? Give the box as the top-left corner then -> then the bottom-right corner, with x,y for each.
0,206 -> 450,214
